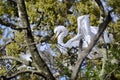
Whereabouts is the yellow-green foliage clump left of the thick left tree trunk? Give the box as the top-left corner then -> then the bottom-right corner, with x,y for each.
6,32 -> 26,56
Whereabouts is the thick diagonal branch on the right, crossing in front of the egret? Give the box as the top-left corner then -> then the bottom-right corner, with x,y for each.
71,0 -> 112,80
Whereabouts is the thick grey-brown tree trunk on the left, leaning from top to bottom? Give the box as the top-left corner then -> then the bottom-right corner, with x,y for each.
16,0 -> 55,80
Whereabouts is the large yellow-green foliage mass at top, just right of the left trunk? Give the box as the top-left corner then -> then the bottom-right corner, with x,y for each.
26,0 -> 67,27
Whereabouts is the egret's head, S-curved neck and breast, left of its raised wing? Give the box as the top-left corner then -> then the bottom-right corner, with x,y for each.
54,25 -> 82,54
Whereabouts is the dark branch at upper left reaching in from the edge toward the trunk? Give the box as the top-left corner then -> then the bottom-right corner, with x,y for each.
0,18 -> 26,31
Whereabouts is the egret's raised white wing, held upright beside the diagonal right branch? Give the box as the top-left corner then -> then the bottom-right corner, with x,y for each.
77,15 -> 93,48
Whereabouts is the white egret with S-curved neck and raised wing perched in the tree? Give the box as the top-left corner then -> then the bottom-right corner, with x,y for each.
54,15 -> 113,53
